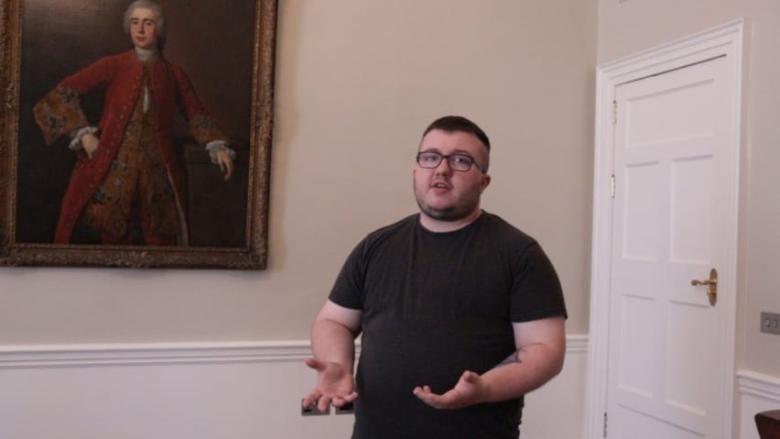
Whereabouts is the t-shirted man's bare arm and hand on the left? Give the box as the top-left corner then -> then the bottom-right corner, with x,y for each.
303,300 -> 362,411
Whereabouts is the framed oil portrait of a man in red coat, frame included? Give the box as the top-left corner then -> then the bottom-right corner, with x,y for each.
0,0 -> 276,269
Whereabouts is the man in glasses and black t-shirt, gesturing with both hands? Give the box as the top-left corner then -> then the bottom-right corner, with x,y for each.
303,116 -> 566,439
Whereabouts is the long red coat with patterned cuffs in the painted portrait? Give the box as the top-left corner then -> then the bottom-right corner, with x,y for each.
33,50 -> 225,244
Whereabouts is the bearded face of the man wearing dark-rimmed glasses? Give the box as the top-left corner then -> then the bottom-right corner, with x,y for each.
412,130 -> 490,221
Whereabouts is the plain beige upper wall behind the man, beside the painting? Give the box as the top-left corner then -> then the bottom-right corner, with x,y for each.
0,0 -> 597,344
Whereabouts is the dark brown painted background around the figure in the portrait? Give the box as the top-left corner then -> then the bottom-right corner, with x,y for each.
16,0 -> 255,247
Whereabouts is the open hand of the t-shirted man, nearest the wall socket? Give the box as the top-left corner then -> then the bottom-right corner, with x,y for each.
303,358 -> 357,412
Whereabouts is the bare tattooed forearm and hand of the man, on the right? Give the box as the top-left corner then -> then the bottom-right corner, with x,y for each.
414,317 -> 566,409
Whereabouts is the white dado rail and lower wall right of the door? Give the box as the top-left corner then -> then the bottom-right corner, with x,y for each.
737,370 -> 780,439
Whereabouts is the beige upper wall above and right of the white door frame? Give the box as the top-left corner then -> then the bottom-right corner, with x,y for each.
598,0 -> 780,376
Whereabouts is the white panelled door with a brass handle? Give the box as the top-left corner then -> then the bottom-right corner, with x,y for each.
607,57 -> 738,439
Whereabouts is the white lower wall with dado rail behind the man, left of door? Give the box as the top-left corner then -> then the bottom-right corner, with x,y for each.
0,335 -> 587,439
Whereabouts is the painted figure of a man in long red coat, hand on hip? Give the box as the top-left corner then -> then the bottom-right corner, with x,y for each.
33,0 -> 235,245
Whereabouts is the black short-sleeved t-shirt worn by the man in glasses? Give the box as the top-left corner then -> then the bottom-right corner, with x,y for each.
330,212 -> 566,439
